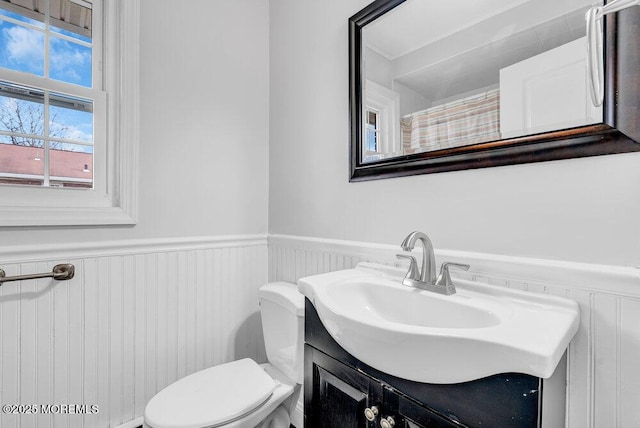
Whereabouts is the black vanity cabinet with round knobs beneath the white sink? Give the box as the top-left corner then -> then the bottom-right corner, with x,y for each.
304,300 -> 542,428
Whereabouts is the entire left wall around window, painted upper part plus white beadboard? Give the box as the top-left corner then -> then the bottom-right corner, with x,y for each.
0,0 -> 269,428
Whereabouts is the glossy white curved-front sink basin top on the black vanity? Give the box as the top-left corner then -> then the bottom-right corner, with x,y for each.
298,264 -> 579,383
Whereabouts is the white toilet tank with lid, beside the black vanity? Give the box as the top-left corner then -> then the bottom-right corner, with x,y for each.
258,282 -> 304,384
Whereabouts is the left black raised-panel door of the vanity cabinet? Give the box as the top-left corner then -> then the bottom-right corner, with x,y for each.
304,345 -> 382,428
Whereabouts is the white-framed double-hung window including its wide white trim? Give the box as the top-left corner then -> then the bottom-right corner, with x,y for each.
0,0 -> 139,226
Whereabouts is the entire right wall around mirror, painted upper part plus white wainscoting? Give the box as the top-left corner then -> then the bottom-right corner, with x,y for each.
269,0 -> 640,428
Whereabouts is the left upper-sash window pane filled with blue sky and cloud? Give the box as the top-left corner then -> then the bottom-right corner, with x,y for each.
0,20 -> 44,76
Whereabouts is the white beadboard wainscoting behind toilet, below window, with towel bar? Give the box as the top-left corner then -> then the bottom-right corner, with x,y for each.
0,235 -> 268,428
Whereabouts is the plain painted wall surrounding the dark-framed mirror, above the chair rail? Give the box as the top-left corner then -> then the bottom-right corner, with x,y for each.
269,0 -> 640,266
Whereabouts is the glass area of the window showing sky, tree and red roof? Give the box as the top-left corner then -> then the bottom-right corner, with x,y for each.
0,0 -> 94,192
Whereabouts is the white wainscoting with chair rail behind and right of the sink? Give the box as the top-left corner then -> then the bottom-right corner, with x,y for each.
269,235 -> 640,428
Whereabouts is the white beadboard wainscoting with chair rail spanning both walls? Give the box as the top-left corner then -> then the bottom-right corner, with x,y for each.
0,235 -> 640,428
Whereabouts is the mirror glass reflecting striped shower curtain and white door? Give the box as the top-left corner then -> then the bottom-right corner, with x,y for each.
360,0 -> 603,163
